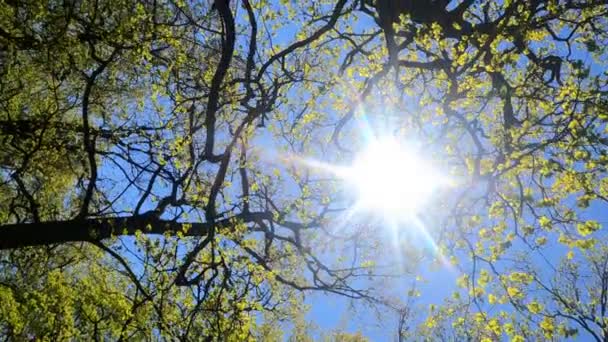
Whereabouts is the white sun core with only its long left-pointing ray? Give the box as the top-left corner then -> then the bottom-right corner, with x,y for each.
292,135 -> 453,219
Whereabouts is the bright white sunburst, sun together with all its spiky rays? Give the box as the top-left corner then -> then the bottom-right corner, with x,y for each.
282,125 -> 453,270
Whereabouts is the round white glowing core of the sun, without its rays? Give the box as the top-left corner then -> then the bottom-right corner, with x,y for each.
344,137 -> 445,218
